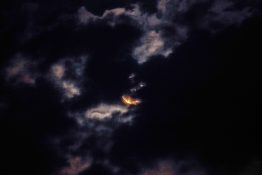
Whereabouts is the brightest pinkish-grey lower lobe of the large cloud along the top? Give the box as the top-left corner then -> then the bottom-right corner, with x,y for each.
133,30 -> 172,64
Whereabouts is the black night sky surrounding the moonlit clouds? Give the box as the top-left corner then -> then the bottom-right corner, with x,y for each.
0,0 -> 262,175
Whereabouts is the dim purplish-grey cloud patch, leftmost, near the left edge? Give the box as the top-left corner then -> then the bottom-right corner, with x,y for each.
5,54 -> 39,86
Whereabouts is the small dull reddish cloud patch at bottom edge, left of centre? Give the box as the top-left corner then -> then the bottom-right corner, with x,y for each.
59,156 -> 92,175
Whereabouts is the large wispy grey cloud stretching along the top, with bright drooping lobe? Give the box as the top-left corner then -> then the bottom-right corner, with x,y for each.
74,0 -> 253,64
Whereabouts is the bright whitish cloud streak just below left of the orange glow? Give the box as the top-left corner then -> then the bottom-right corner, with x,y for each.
85,104 -> 128,120
